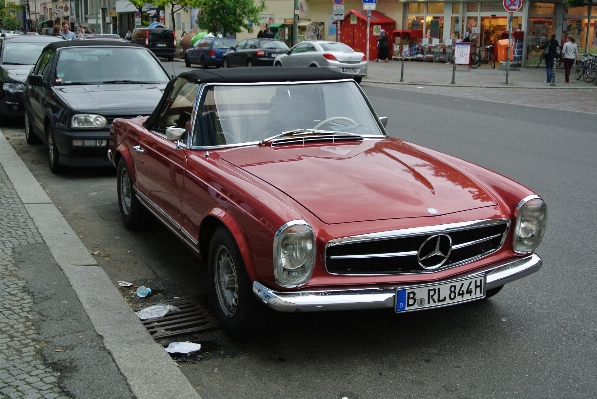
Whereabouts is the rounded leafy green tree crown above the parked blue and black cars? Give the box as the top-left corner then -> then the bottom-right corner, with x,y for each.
193,0 -> 266,36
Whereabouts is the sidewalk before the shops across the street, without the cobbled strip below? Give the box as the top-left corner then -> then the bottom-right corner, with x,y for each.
363,60 -> 597,89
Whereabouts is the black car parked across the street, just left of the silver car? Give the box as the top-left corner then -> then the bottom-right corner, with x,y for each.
222,39 -> 289,68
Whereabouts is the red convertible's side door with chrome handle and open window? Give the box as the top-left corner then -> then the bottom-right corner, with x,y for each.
131,78 -> 199,228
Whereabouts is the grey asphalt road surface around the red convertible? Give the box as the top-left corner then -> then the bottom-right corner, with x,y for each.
2,68 -> 597,399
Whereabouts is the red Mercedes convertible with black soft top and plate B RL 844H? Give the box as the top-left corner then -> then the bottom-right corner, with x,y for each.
108,68 -> 547,337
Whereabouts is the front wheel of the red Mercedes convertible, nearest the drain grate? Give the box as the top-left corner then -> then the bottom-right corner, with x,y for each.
207,227 -> 270,341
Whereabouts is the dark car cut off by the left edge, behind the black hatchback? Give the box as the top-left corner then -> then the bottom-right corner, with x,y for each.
0,35 -> 64,119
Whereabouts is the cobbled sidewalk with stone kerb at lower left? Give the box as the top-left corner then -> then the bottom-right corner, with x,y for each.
0,131 -> 200,399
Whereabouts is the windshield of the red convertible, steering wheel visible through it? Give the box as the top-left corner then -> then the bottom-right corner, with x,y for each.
193,82 -> 384,146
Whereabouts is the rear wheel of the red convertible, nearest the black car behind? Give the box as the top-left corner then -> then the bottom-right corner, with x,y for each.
116,158 -> 150,230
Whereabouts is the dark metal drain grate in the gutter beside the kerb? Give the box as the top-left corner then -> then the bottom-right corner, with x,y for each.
133,298 -> 219,338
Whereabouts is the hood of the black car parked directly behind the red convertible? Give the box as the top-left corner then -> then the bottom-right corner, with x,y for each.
54,83 -> 166,115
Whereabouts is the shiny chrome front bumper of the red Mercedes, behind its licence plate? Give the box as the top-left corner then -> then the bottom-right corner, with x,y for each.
253,254 -> 543,312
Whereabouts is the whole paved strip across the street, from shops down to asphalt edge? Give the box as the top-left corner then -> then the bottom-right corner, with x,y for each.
364,61 -> 597,114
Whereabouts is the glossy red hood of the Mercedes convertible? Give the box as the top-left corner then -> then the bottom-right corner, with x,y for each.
221,139 -> 496,224
